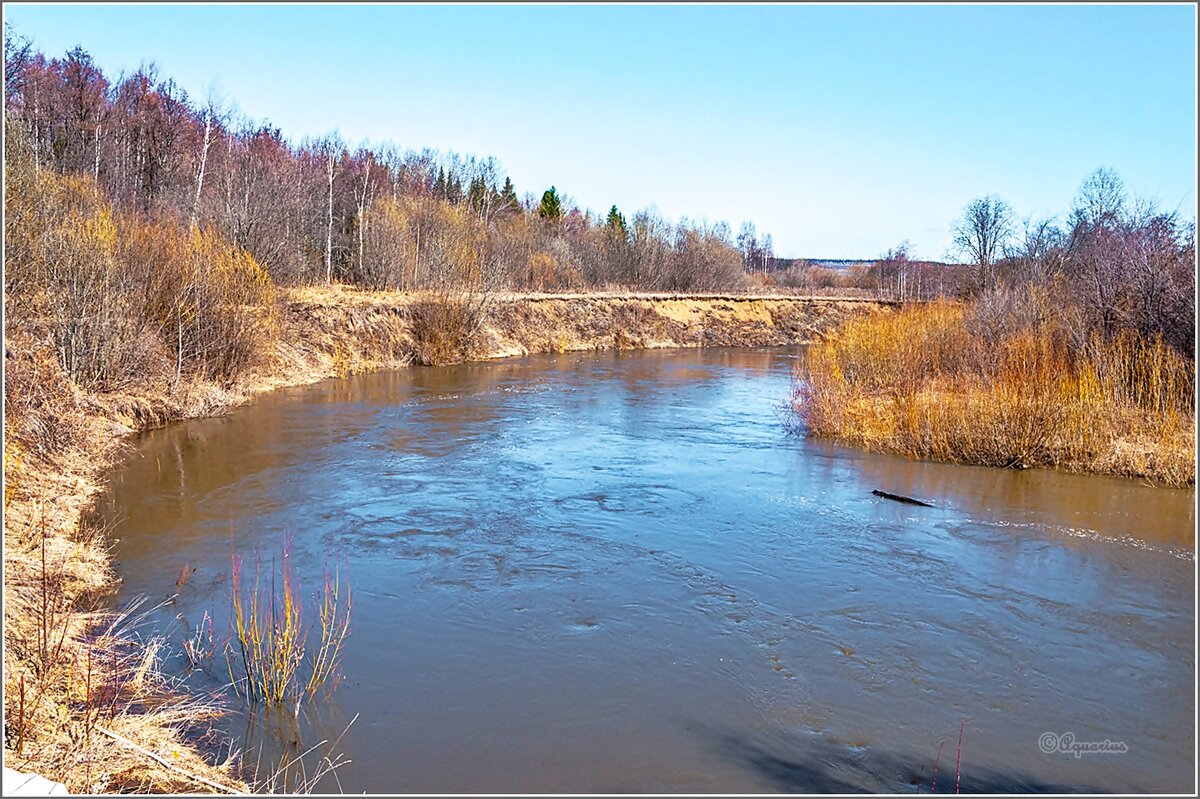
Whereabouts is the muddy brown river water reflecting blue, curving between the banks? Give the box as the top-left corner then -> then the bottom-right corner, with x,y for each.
96,349 -> 1195,792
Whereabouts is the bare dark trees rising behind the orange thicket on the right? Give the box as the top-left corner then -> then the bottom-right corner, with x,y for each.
953,167 -> 1196,359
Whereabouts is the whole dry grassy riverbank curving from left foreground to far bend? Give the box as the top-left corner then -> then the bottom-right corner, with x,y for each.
4,287 -> 886,793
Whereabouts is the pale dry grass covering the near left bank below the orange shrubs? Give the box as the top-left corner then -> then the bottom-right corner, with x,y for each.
4,336 -> 246,793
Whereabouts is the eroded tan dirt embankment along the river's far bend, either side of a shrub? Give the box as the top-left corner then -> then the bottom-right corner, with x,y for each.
281,288 -> 889,364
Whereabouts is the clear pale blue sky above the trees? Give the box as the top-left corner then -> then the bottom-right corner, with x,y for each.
5,4 -> 1196,258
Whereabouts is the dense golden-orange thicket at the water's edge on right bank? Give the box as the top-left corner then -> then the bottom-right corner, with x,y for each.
793,296 -> 1195,486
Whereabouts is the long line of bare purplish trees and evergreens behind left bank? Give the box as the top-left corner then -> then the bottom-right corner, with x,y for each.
5,29 -> 769,292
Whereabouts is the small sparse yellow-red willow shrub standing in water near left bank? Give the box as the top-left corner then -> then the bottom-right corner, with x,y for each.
226,542 -> 352,704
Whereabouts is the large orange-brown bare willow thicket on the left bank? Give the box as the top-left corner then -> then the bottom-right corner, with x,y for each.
5,118 -> 275,389
